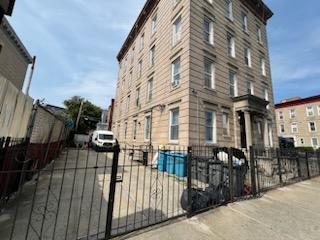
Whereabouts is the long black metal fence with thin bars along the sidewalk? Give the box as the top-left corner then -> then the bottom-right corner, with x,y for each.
0,143 -> 320,239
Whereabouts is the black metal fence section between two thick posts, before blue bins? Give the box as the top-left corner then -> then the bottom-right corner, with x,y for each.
106,147 -> 187,239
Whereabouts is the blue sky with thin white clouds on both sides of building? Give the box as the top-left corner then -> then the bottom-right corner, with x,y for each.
9,0 -> 320,108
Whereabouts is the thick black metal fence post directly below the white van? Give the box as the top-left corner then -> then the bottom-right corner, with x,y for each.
105,143 -> 120,239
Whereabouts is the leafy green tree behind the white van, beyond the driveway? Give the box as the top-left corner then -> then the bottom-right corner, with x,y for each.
63,96 -> 102,134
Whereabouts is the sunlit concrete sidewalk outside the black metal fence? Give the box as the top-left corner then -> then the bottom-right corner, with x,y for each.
129,178 -> 320,240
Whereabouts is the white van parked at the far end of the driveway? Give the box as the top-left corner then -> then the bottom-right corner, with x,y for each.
91,130 -> 116,151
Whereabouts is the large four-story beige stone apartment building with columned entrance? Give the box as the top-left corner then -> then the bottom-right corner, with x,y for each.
113,0 -> 278,148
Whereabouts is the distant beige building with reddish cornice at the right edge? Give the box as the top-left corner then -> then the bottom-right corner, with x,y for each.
276,95 -> 320,148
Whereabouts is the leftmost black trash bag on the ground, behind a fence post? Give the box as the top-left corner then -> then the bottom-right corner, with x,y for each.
180,188 -> 210,212
